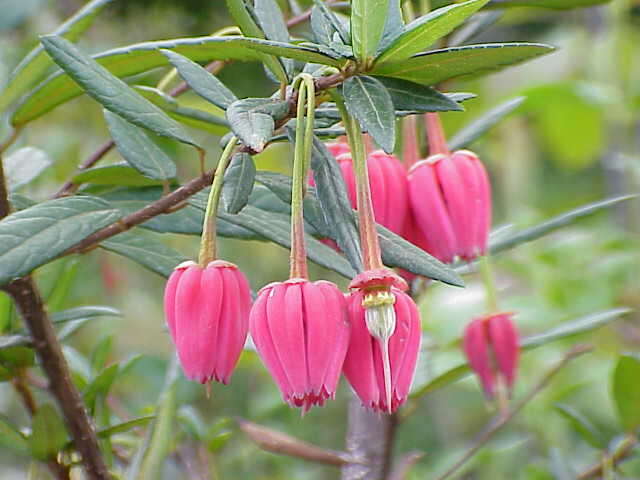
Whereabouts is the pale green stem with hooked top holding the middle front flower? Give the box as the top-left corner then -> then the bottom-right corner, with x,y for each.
289,74 -> 315,278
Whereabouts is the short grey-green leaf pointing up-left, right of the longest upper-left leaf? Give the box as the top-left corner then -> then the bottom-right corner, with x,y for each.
160,50 -> 237,110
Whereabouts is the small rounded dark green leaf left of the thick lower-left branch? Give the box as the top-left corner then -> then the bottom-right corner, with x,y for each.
28,403 -> 68,460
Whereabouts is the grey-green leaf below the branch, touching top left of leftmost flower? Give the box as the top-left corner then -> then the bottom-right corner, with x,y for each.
100,230 -> 188,277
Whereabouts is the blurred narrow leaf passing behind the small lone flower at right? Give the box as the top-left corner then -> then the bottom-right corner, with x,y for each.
411,308 -> 630,398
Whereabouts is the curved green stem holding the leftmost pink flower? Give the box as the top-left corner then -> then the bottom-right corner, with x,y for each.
198,136 -> 238,267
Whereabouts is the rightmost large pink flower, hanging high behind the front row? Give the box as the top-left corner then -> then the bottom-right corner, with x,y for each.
409,150 -> 491,263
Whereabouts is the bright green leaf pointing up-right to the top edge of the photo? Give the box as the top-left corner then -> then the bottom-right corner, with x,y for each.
376,0 -> 489,64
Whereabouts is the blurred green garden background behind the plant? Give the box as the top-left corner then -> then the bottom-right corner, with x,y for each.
0,0 -> 640,480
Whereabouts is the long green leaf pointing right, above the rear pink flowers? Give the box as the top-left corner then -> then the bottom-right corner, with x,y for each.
370,43 -> 553,85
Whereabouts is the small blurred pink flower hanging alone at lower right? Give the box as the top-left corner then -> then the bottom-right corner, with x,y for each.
463,313 -> 520,398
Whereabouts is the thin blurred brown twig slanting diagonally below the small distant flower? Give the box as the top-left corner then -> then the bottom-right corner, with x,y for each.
436,345 -> 593,480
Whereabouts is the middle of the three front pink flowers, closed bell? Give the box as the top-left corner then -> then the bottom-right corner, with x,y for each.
250,278 -> 350,412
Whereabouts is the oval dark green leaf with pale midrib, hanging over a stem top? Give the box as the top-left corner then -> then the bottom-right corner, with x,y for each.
342,76 -> 396,153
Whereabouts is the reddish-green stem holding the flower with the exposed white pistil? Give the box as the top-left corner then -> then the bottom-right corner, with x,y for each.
333,93 -> 384,270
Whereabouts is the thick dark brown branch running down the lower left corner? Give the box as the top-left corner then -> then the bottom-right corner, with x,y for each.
3,277 -> 111,480
